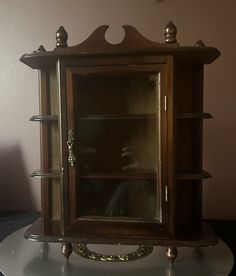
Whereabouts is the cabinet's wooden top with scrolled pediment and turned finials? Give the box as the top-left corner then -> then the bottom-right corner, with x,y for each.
20,22 -> 220,69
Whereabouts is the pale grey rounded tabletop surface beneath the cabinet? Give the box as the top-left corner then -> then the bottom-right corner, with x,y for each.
0,227 -> 233,276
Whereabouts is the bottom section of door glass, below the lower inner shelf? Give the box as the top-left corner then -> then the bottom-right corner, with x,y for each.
80,179 -> 159,219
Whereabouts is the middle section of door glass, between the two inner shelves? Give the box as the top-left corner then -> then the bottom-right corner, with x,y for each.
77,118 -> 157,173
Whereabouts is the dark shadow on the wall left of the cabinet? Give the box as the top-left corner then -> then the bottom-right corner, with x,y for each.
0,145 -> 36,211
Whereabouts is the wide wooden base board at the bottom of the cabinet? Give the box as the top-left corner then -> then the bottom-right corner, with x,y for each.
24,218 -> 218,247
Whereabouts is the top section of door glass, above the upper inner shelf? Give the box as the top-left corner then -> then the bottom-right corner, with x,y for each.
74,74 -> 156,117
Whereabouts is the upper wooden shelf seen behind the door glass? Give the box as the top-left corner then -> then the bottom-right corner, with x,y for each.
80,114 -> 156,120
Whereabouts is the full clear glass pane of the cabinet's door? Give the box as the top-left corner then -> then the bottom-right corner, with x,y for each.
74,73 -> 161,220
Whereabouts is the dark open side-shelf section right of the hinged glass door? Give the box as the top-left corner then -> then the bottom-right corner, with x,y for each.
175,63 -> 206,227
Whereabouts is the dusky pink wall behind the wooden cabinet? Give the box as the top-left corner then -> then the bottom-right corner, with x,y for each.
0,0 -> 236,219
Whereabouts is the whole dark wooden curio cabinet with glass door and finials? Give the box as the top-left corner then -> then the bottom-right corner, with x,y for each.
21,22 -> 220,260
